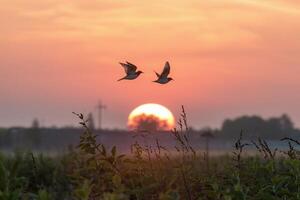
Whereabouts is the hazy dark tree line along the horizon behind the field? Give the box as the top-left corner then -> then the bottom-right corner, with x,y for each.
0,114 -> 300,150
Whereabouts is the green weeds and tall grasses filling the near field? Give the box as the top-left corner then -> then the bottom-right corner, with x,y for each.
0,109 -> 300,200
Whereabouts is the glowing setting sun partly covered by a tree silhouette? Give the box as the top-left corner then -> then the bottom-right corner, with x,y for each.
128,103 -> 175,131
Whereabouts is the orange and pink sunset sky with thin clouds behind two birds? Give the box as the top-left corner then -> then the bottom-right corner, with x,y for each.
0,0 -> 300,128
